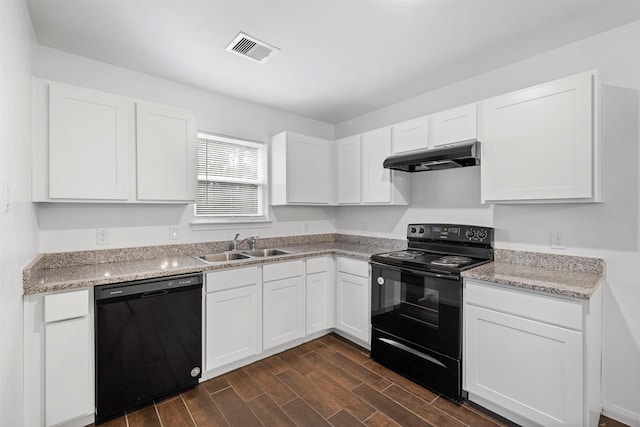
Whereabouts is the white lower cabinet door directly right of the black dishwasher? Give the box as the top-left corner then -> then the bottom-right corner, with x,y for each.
205,284 -> 259,371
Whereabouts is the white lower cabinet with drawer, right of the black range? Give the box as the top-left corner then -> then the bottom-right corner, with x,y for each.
463,280 -> 600,427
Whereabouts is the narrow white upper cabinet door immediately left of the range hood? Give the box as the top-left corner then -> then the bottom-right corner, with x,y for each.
362,127 -> 392,203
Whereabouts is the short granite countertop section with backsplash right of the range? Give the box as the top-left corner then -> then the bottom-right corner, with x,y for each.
462,249 -> 604,299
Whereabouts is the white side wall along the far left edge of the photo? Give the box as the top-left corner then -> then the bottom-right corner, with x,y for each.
0,0 -> 38,426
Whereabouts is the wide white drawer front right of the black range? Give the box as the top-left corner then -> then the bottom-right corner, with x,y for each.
465,280 -> 582,331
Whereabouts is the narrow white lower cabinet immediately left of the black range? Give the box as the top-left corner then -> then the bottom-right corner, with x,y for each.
335,257 -> 371,343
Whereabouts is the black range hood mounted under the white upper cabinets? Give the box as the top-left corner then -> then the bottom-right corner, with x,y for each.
383,139 -> 480,172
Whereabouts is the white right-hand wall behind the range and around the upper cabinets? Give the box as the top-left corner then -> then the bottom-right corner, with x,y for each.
336,22 -> 640,425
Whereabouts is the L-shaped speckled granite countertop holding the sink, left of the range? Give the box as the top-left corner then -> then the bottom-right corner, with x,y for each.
23,238 -> 403,295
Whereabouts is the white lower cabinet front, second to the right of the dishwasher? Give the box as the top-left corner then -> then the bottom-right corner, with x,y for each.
262,260 -> 305,350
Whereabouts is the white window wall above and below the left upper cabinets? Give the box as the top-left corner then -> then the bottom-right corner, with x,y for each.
33,46 -> 335,252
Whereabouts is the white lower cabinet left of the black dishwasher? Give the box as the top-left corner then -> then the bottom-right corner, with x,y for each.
24,289 -> 94,426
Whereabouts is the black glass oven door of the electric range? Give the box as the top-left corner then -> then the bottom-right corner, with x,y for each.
371,262 -> 462,359
